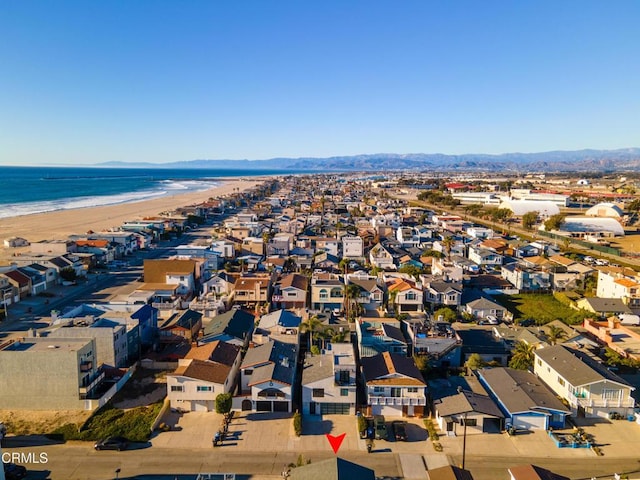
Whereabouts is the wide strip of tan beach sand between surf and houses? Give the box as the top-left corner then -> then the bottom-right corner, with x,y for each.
0,178 -> 264,265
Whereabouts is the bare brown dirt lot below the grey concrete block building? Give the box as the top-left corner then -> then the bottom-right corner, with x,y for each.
0,410 -> 91,435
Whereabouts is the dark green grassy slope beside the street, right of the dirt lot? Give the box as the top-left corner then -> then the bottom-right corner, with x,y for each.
48,402 -> 162,442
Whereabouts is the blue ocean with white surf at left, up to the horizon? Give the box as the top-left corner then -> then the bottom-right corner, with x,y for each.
0,166 -> 309,218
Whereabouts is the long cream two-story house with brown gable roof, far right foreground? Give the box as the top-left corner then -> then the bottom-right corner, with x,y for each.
533,345 -> 635,418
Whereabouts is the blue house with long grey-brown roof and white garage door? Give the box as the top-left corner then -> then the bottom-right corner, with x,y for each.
477,366 -> 571,430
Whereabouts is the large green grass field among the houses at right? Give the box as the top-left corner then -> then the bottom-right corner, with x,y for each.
496,293 -> 593,325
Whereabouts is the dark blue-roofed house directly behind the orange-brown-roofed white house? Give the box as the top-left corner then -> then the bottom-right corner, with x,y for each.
356,317 -> 408,358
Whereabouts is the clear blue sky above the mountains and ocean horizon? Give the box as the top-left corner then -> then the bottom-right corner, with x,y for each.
0,0 -> 640,165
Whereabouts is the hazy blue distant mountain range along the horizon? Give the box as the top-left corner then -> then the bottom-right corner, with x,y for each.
97,148 -> 640,172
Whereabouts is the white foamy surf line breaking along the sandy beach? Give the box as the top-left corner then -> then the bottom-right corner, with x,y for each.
0,181 -> 219,218
